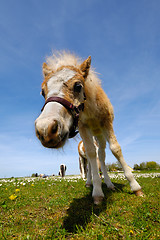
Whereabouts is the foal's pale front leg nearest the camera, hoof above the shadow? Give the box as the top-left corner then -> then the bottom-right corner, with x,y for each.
79,127 -> 104,204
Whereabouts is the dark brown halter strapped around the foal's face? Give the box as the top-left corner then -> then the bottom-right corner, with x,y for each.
41,97 -> 84,138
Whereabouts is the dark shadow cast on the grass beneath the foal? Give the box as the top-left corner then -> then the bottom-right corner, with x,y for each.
63,183 -> 124,233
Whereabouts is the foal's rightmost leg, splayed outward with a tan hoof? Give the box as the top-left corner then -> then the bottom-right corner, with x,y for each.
106,126 -> 143,196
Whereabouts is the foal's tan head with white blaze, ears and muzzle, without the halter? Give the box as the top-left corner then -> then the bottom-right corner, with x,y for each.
35,54 -> 91,148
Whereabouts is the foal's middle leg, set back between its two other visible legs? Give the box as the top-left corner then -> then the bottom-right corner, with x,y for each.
96,136 -> 115,190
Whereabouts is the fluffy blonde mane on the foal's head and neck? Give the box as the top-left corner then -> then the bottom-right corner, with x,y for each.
46,51 -> 101,85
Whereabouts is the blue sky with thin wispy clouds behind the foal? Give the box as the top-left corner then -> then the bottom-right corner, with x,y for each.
0,0 -> 160,177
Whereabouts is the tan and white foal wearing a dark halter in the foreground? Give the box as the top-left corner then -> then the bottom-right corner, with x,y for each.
35,52 -> 143,204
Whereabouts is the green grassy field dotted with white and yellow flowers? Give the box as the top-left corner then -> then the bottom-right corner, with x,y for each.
0,173 -> 160,240
